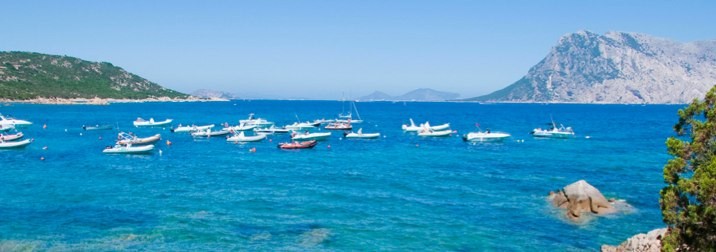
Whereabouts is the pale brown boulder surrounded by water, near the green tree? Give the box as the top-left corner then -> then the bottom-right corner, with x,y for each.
548,180 -> 616,221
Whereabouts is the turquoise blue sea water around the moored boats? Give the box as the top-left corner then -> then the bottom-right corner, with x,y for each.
0,101 -> 681,251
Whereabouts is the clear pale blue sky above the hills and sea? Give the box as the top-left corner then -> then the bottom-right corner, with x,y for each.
0,0 -> 716,99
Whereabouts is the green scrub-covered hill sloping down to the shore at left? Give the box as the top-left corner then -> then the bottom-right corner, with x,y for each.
0,52 -> 188,100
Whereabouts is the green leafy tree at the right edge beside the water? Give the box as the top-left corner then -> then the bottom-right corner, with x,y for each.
659,86 -> 716,251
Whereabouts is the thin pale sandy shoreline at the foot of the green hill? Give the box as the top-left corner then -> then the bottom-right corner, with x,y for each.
0,96 -> 229,105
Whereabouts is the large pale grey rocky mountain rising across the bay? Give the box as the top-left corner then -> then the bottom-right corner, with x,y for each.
467,31 -> 716,103
